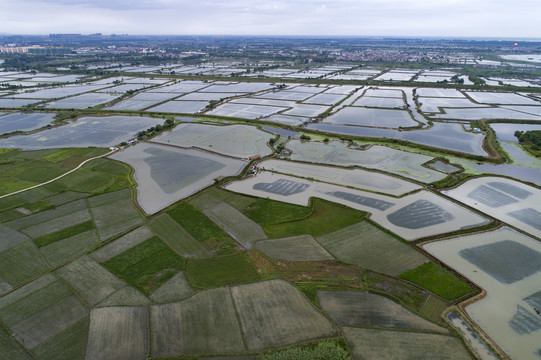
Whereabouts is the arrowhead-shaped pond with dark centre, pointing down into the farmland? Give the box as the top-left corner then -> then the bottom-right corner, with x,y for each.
111,143 -> 246,214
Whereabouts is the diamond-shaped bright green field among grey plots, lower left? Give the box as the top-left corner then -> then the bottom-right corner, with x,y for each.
103,237 -> 184,295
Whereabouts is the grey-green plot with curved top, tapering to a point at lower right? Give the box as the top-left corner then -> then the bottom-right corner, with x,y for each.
317,291 -> 448,333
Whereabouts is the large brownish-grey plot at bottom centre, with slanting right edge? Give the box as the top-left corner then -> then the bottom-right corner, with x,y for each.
231,280 -> 335,351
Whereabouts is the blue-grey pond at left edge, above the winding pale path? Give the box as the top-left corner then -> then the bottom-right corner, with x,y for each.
0,115 -> 161,150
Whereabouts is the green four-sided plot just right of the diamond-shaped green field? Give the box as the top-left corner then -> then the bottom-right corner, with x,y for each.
186,253 -> 261,289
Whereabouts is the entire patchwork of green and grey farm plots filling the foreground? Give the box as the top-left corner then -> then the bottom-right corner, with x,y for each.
0,151 -> 484,360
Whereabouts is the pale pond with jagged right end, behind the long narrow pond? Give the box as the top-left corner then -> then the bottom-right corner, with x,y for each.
287,140 -> 446,183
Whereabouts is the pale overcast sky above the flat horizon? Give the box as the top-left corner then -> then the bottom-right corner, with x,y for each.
0,0 -> 541,38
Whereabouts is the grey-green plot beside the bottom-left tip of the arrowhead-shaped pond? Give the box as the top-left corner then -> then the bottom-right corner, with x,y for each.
90,196 -> 143,241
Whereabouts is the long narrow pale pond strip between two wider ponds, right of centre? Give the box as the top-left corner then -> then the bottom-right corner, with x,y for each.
258,160 -> 421,196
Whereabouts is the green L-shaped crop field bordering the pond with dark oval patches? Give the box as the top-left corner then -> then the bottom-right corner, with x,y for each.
263,198 -> 365,239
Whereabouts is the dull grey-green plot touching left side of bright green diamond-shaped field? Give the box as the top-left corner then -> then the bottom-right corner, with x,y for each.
55,256 -> 124,306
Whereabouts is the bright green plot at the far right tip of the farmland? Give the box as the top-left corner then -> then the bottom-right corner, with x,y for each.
399,262 -> 473,300
